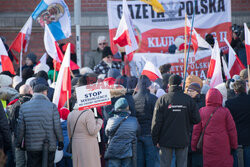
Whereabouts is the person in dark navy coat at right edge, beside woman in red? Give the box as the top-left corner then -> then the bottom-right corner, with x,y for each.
226,79 -> 250,166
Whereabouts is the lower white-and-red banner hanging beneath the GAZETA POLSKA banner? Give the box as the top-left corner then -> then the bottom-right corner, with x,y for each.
130,50 -> 211,79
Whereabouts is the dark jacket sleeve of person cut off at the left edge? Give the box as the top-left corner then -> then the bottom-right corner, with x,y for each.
0,103 -> 11,153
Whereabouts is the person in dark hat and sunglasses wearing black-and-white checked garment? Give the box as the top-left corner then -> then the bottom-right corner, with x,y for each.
94,46 -> 121,76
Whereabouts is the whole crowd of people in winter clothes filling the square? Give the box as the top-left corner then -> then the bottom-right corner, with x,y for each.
0,25 -> 250,167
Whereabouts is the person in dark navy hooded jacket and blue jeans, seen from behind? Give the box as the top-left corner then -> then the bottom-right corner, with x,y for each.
133,75 -> 160,167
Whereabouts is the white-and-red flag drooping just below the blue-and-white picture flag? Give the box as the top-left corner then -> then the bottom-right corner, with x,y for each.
44,25 -> 80,70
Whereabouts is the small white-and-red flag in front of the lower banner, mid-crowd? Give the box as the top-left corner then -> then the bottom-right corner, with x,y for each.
141,61 -> 162,82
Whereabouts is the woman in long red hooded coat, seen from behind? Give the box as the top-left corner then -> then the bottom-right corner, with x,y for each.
191,88 -> 238,167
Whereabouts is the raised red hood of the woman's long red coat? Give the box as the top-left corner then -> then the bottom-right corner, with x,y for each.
206,88 -> 223,107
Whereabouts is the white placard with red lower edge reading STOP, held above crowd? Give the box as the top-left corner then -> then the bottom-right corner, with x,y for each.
76,83 -> 111,110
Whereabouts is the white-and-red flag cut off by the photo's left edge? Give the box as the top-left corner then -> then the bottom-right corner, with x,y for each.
0,38 -> 15,74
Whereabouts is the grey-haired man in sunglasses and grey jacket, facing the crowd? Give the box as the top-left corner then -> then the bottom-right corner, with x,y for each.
84,36 -> 108,69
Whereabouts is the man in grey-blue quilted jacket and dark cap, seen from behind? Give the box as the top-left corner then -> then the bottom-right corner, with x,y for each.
16,84 -> 63,167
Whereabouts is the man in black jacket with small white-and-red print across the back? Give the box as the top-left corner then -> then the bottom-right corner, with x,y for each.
151,75 -> 200,167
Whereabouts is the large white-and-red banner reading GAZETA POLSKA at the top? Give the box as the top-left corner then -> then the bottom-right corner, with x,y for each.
107,0 -> 232,53
